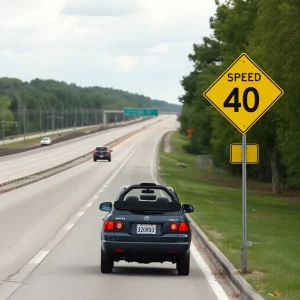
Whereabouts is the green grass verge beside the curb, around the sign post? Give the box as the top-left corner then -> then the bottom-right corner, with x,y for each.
160,132 -> 300,300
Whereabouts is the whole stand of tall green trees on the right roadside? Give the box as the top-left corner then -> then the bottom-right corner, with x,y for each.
179,0 -> 300,193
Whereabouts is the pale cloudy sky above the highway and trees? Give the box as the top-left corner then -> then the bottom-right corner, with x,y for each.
0,0 -> 216,103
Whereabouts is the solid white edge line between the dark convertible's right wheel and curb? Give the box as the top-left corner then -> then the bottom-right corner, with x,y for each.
191,243 -> 229,300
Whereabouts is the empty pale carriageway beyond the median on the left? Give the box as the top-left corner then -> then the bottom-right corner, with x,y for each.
0,115 -> 164,184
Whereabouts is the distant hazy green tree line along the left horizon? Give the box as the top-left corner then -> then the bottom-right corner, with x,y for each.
0,78 -> 182,139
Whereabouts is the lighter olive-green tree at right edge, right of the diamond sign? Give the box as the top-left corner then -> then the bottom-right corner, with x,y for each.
249,0 -> 300,192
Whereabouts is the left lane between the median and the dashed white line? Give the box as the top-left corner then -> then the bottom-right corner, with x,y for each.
0,128 -> 149,280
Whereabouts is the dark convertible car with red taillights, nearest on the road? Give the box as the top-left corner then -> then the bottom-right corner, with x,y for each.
99,183 -> 194,275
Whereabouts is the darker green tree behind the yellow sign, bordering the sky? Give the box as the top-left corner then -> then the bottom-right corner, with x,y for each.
179,0 -> 284,193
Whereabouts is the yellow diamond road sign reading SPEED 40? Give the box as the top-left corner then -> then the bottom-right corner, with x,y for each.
203,53 -> 284,134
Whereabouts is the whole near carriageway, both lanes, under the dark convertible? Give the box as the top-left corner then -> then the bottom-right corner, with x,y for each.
0,116 -> 234,300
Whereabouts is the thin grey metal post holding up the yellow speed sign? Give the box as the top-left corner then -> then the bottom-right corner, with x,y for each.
241,134 -> 247,274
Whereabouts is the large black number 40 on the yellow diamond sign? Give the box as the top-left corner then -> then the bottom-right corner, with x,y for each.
223,87 -> 259,112
